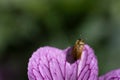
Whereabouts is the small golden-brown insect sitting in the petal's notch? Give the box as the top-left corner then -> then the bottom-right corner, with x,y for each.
72,39 -> 85,60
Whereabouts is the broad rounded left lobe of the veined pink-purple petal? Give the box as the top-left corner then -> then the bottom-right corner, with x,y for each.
28,47 -> 66,80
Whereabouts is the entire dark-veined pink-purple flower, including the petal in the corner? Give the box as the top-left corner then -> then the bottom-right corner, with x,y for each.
28,41 -> 120,80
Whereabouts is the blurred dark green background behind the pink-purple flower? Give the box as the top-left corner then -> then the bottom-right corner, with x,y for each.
0,0 -> 120,80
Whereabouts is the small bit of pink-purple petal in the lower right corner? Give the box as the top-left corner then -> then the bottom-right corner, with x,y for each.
99,69 -> 120,80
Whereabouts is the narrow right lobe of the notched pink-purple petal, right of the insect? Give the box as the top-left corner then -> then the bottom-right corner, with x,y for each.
77,45 -> 98,80
